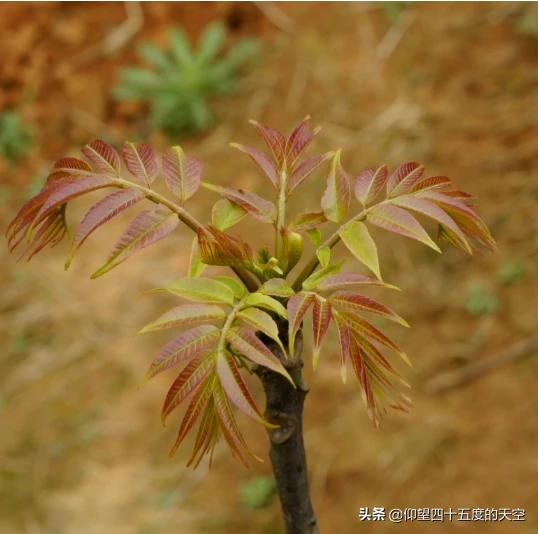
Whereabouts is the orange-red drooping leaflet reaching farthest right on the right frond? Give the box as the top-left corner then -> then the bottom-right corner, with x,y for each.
419,191 -> 496,250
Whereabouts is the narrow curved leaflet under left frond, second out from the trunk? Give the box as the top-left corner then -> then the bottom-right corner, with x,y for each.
65,189 -> 144,269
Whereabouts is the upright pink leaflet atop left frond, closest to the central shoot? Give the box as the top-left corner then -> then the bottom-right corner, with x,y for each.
162,145 -> 203,202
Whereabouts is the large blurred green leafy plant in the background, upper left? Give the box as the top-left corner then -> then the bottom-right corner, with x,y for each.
114,22 -> 257,136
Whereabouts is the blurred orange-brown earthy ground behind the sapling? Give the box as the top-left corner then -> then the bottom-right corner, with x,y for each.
0,2 -> 538,534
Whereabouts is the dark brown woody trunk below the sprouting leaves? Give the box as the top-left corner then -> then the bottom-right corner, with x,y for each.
255,330 -> 318,534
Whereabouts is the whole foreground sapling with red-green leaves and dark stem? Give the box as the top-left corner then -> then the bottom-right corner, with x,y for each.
7,117 -> 495,533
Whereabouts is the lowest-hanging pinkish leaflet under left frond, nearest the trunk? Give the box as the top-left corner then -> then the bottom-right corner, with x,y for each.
92,208 -> 179,278
